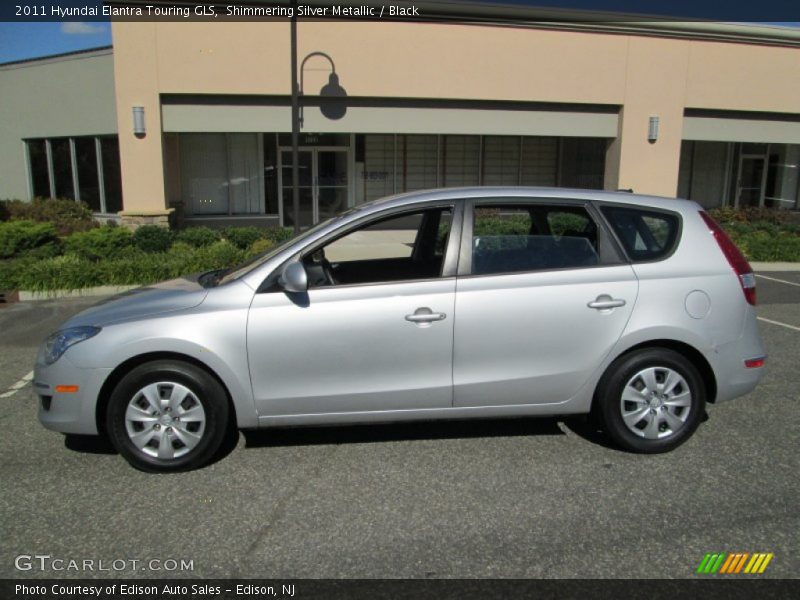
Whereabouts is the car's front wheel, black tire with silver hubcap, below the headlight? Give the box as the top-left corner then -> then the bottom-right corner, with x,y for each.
106,360 -> 230,473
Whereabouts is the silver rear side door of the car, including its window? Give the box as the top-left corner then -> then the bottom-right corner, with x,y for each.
453,198 -> 638,406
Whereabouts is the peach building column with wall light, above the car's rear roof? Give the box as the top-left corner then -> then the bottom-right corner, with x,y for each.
605,37 -> 689,197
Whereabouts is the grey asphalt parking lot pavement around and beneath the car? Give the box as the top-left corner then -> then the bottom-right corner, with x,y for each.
0,273 -> 800,578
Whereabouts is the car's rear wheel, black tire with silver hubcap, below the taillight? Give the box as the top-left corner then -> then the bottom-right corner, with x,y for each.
593,348 -> 706,454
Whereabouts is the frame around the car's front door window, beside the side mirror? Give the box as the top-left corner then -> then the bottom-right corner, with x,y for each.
256,199 -> 464,294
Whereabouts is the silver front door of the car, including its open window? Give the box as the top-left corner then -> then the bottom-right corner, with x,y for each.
247,204 -> 457,419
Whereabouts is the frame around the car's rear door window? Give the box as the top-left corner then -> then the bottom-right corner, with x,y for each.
458,196 -> 629,278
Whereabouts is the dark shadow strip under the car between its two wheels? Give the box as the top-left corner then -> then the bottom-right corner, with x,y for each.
243,417 -> 564,448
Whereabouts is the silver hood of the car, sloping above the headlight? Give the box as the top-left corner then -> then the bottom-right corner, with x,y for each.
60,275 -> 208,329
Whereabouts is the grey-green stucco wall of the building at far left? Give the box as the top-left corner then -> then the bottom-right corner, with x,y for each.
0,50 -> 117,199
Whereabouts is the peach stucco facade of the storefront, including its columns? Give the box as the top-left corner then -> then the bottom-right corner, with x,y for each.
113,22 -> 800,209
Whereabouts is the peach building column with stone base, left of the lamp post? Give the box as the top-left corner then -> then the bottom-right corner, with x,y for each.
111,21 -> 171,228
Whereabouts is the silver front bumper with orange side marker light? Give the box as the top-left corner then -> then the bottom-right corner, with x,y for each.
33,353 -> 112,435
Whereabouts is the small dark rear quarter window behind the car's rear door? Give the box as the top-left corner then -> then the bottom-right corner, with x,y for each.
601,206 -> 680,262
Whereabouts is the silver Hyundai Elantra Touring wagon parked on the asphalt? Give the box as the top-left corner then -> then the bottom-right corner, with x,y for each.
34,188 -> 765,471
